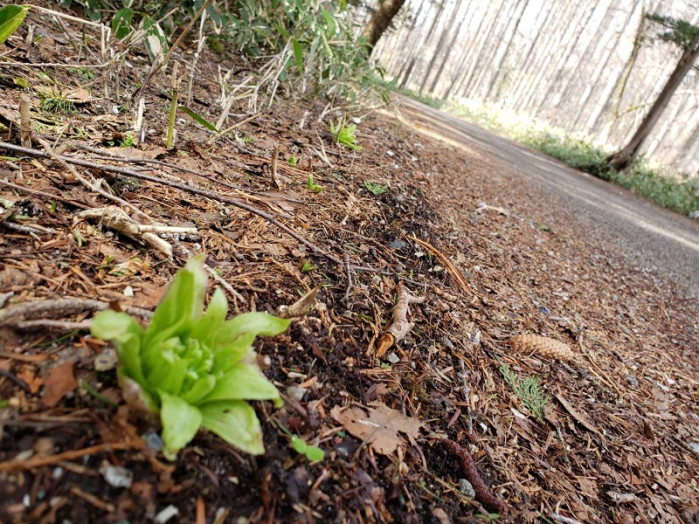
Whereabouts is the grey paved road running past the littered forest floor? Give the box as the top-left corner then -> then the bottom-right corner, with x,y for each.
398,98 -> 699,298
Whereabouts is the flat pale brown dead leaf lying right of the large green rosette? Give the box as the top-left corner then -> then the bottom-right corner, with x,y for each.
330,402 -> 422,455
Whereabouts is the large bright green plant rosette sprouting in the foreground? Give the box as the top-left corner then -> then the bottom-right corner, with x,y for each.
91,255 -> 289,460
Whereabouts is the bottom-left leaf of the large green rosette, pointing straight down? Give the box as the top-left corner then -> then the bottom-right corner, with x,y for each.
160,392 -> 204,458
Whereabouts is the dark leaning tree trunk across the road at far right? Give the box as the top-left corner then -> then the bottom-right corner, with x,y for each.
606,40 -> 699,171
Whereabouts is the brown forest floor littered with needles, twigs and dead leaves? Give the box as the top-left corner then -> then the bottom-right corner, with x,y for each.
0,9 -> 699,524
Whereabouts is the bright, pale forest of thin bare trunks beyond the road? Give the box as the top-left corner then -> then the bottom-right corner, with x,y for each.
373,0 -> 699,176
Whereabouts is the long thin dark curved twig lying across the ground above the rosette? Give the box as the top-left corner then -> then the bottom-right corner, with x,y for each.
0,142 -> 342,265
